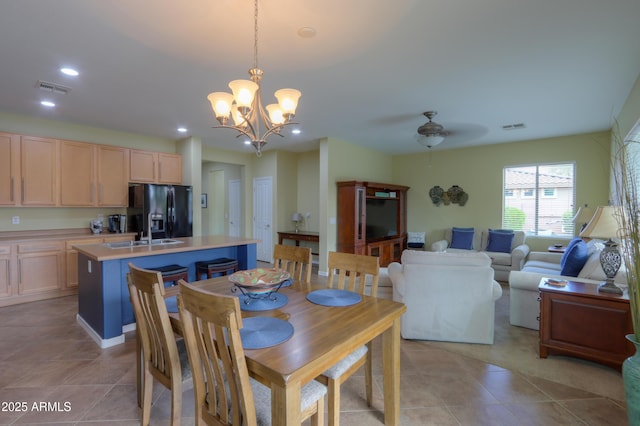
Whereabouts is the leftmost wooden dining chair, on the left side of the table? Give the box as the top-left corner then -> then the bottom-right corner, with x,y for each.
127,263 -> 191,426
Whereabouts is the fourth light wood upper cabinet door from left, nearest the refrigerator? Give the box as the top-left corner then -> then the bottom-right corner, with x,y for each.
96,145 -> 129,207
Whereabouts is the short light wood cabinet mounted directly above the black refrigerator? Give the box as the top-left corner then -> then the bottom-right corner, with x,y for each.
129,149 -> 182,185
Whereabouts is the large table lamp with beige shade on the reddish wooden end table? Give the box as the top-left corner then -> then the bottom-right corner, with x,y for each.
580,206 -> 622,294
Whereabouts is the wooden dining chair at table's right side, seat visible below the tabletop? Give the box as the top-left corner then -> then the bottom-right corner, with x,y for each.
316,252 -> 380,426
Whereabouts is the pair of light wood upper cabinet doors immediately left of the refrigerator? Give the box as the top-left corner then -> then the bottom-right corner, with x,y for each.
60,141 -> 129,207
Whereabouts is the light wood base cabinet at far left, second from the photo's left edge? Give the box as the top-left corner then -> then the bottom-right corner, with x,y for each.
18,241 -> 65,295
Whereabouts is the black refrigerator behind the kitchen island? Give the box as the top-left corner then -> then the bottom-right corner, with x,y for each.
127,183 -> 193,239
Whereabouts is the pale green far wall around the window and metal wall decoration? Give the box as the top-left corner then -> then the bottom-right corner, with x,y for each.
393,132 -> 610,250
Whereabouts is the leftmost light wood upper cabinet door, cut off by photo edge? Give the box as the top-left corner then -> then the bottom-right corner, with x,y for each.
0,133 -> 21,206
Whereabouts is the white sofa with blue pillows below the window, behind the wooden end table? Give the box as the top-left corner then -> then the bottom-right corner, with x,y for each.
509,240 -> 627,330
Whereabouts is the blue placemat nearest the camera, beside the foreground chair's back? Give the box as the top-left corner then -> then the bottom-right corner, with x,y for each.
240,317 -> 293,349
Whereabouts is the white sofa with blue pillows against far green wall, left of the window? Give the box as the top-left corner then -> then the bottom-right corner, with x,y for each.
431,228 -> 529,282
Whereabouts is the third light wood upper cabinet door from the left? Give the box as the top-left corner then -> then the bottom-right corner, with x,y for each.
60,141 -> 97,207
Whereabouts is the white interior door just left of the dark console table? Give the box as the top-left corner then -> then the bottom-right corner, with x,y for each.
253,176 -> 273,263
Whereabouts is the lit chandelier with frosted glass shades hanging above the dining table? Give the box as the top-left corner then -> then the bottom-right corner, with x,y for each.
207,0 -> 301,157
